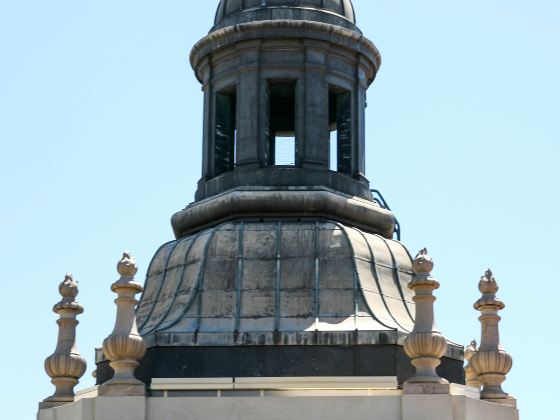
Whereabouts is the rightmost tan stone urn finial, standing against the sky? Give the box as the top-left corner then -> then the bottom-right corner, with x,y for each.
471,270 -> 514,405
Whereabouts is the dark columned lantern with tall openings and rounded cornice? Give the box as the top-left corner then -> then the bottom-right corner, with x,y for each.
191,16 -> 381,200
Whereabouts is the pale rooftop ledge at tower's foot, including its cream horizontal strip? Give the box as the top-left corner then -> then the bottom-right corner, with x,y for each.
37,377 -> 519,420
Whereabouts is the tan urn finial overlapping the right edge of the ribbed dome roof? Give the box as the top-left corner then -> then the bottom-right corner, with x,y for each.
404,249 -> 449,393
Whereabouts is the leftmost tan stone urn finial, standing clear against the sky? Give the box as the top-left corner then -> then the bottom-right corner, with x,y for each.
40,274 -> 87,408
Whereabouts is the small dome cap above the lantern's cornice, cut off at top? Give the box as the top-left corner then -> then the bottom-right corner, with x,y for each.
213,0 -> 356,30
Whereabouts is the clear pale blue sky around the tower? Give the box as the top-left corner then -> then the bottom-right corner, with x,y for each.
0,0 -> 560,420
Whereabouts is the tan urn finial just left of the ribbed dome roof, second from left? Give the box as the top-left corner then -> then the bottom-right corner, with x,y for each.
99,252 -> 146,396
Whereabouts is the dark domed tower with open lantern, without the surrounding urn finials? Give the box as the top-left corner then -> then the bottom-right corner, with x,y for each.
97,0 -> 463,384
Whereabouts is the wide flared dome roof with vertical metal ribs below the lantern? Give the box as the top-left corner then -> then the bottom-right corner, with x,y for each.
137,221 -> 414,347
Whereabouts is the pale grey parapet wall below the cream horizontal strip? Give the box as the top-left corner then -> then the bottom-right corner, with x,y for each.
38,390 -> 519,420
